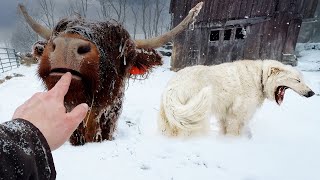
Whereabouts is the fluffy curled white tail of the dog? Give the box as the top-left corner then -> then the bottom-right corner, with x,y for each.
162,87 -> 212,131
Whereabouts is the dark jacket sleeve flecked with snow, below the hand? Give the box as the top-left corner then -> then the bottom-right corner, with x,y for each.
0,119 -> 56,180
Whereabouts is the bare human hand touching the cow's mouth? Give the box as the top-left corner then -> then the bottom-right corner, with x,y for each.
13,73 -> 88,151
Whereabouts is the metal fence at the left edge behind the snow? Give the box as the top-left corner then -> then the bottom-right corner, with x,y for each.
0,48 -> 20,73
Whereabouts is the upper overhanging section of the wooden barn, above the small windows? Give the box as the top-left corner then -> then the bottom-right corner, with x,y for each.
170,0 -> 318,22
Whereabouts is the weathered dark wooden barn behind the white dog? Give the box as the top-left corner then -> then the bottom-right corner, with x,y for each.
170,0 -> 318,70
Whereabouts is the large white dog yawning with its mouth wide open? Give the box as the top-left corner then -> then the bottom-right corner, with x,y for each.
158,60 -> 314,136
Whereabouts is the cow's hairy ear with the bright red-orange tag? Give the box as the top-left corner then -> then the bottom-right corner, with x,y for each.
130,49 -> 163,76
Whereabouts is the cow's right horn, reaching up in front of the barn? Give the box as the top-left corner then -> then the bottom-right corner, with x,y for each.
135,2 -> 203,48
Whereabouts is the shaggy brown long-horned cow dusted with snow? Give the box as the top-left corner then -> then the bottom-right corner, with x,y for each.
19,3 -> 203,145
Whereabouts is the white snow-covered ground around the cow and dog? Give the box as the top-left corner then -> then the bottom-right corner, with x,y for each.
0,50 -> 320,180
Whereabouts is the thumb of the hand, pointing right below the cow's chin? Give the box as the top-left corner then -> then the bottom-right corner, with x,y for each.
67,103 -> 89,130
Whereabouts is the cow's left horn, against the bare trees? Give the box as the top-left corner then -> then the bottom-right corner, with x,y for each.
18,4 -> 52,40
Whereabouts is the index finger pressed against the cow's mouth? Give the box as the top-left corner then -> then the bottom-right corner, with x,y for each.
49,72 -> 72,99
